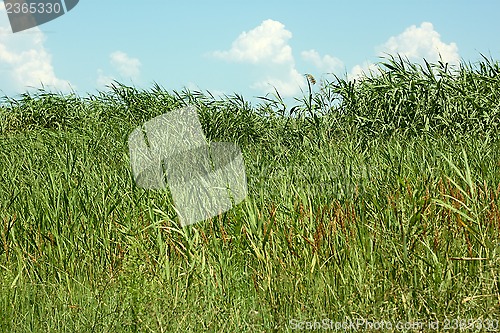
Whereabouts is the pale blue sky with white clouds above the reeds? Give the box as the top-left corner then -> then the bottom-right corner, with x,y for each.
0,0 -> 500,100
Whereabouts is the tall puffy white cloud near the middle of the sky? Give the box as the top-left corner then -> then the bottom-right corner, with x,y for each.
212,20 -> 305,97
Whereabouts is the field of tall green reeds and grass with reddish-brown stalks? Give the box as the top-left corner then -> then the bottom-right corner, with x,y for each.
0,57 -> 500,332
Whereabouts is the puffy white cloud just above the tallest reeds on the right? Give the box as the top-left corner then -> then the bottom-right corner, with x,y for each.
379,22 -> 460,65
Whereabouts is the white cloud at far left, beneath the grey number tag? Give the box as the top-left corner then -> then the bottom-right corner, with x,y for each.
0,2 -> 71,92
